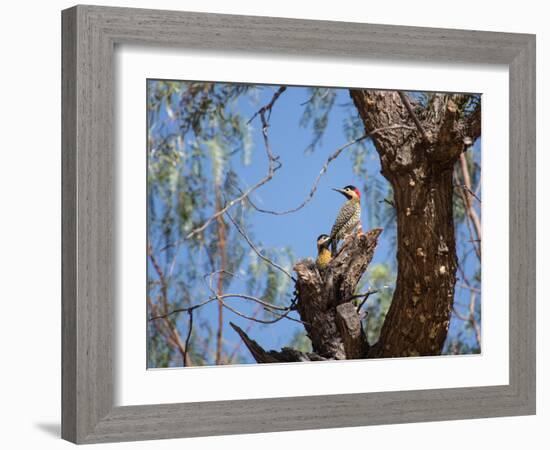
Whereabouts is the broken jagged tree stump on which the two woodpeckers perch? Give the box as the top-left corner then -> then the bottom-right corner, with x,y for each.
231,228 -> 382,363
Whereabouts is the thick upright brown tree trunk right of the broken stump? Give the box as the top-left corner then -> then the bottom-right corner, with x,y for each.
350,90 -> 481,357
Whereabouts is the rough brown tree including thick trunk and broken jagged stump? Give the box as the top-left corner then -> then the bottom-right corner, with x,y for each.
233,89 -> 481,362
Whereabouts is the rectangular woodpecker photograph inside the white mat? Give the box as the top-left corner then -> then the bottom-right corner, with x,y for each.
148,79 -> 483,369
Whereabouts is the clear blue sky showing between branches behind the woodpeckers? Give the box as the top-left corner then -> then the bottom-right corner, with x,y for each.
149,81 -> 480,361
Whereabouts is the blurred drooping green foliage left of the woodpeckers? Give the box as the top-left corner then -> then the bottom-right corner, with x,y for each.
147,80 -> 292,367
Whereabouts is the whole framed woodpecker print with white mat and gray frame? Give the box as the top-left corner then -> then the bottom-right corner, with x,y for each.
62,6 -> 535,443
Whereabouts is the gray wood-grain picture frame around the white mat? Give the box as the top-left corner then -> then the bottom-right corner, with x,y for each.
62,6 -> 535,443
